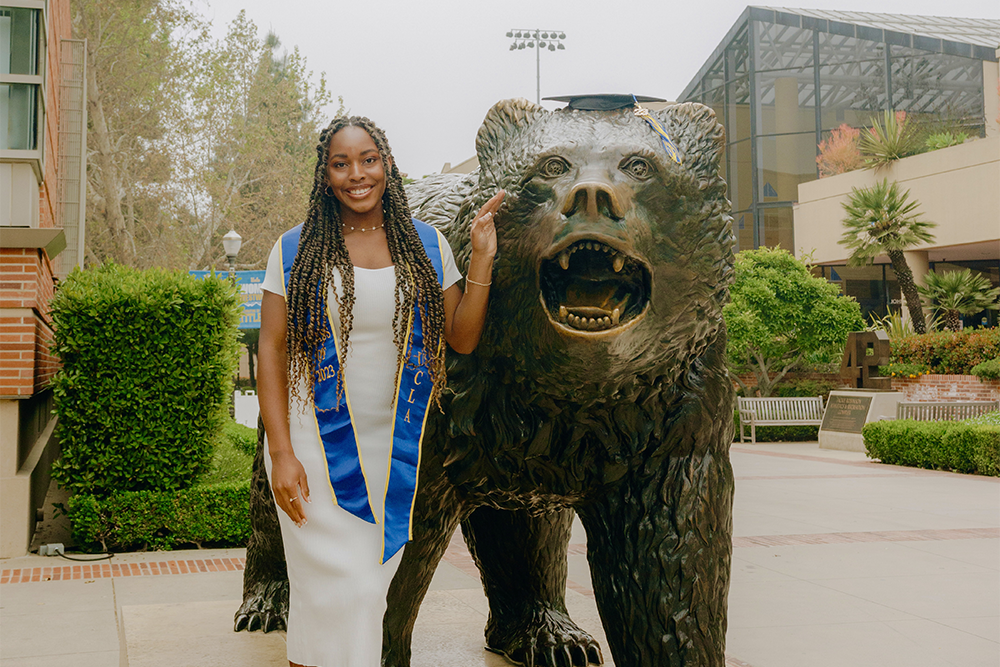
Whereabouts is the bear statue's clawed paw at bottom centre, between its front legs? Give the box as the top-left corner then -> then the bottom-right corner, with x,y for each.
486,608 -> 604,667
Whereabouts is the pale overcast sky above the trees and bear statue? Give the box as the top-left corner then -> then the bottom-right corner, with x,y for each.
195,0 -> 1000,177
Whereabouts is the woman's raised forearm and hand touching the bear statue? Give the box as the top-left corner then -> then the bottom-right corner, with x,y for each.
444,190 -> 506,354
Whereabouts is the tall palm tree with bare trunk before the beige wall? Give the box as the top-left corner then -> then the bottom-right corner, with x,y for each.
839,179 -> 935,334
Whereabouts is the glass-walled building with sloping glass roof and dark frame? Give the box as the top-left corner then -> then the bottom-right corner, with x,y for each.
679,7 -> 1000,258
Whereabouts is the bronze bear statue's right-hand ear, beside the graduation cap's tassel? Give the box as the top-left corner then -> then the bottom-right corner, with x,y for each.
652,102 -> 726,184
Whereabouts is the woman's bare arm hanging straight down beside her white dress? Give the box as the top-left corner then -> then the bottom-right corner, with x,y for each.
257,290 -> 309,526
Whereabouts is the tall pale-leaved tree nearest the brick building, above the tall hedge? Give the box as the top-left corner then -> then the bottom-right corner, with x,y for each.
73,0 -> 206,268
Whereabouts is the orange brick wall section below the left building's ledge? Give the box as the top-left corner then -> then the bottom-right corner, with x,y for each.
0,248 -> 58,396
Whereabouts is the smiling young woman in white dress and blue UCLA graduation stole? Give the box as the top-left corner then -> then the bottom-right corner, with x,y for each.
259,117 -> 504,667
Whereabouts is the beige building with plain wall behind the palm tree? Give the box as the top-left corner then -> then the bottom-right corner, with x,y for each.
794,55 -> 1000,326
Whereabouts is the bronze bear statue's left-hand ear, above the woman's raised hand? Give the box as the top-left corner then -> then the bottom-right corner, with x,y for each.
476,98 -> 548,187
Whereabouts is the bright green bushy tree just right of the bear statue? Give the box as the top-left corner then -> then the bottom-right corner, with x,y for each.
722,248 -> 864,396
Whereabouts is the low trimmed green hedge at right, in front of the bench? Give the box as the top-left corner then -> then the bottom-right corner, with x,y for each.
862,413 -> 1000,475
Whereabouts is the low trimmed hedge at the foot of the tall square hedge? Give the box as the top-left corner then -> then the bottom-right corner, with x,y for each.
69,480 -> 250,552
